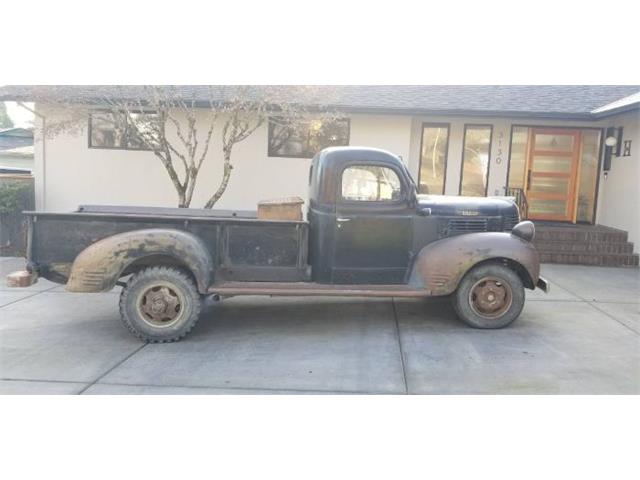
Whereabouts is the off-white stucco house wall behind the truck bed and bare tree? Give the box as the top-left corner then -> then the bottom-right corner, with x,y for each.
35,106 -> 411,215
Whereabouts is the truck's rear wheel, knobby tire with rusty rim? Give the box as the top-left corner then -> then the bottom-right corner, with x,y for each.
120,267 -> 201,343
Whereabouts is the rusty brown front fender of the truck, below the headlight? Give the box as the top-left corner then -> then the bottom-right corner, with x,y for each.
409,232 -> 540,296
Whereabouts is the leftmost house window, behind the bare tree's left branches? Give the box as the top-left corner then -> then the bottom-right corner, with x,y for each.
89,112 -> 157,150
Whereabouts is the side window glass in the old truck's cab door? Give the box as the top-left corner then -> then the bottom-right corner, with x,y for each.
342,165 -> 402,202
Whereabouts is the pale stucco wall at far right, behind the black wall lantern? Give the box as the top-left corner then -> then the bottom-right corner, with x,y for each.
596,112 -> 640,249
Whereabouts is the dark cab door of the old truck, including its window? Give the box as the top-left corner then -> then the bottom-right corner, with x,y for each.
332,164 -> 414,284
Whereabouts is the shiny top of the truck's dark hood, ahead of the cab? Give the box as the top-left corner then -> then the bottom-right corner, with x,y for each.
417,195 -> 518,216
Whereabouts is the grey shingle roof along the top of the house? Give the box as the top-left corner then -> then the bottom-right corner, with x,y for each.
0,85 -> 640,119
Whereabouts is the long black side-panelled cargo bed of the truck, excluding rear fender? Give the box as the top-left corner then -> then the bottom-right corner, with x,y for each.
25,205 -> 310,283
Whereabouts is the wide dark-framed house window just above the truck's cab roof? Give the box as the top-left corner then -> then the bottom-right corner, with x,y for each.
268,117 -> 349,158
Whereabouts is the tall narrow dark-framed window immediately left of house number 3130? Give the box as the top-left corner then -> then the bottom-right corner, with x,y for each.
460,125 -> 493,197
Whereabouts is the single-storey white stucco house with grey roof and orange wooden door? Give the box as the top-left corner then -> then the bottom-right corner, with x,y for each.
0,85 -> 640,265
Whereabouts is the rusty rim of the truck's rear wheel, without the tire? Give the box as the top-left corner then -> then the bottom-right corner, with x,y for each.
137,283 -> 185,328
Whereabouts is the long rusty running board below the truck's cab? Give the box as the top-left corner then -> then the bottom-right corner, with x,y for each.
208,282 -> 429,297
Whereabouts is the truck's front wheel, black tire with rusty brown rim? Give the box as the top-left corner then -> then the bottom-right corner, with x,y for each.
452,263 -> 525,328
